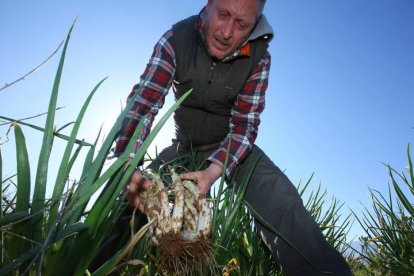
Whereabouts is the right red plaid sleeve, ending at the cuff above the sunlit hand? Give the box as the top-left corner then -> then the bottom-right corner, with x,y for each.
208,52 -> 271,178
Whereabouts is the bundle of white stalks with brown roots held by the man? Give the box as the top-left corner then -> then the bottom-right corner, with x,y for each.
140,169 -> 211,274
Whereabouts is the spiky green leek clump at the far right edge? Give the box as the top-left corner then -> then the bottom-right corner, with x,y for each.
355,145 -> 414,275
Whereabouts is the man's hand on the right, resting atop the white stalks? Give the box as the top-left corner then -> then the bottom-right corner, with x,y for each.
180,163 -> 223,195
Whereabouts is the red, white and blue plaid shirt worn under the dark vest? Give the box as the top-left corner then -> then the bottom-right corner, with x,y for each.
115,30 -> 271,178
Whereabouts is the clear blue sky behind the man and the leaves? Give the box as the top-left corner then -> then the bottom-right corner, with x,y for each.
0,0 -> 414,239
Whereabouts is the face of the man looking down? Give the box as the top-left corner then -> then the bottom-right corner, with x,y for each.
204,0 -> 263,59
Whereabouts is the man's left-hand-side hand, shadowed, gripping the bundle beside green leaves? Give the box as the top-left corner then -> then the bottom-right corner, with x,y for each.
124,171 -> 151,213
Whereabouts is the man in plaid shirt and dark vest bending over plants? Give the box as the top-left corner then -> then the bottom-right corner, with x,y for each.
115,0 -> 351,275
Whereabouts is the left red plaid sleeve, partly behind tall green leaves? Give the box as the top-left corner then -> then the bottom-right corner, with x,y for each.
114,30 -> 175,156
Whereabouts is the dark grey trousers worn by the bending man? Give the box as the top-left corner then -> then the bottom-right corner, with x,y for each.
159,143 -> 352,276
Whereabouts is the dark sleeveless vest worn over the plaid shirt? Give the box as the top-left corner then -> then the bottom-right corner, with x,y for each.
172,16 -> 268,146
